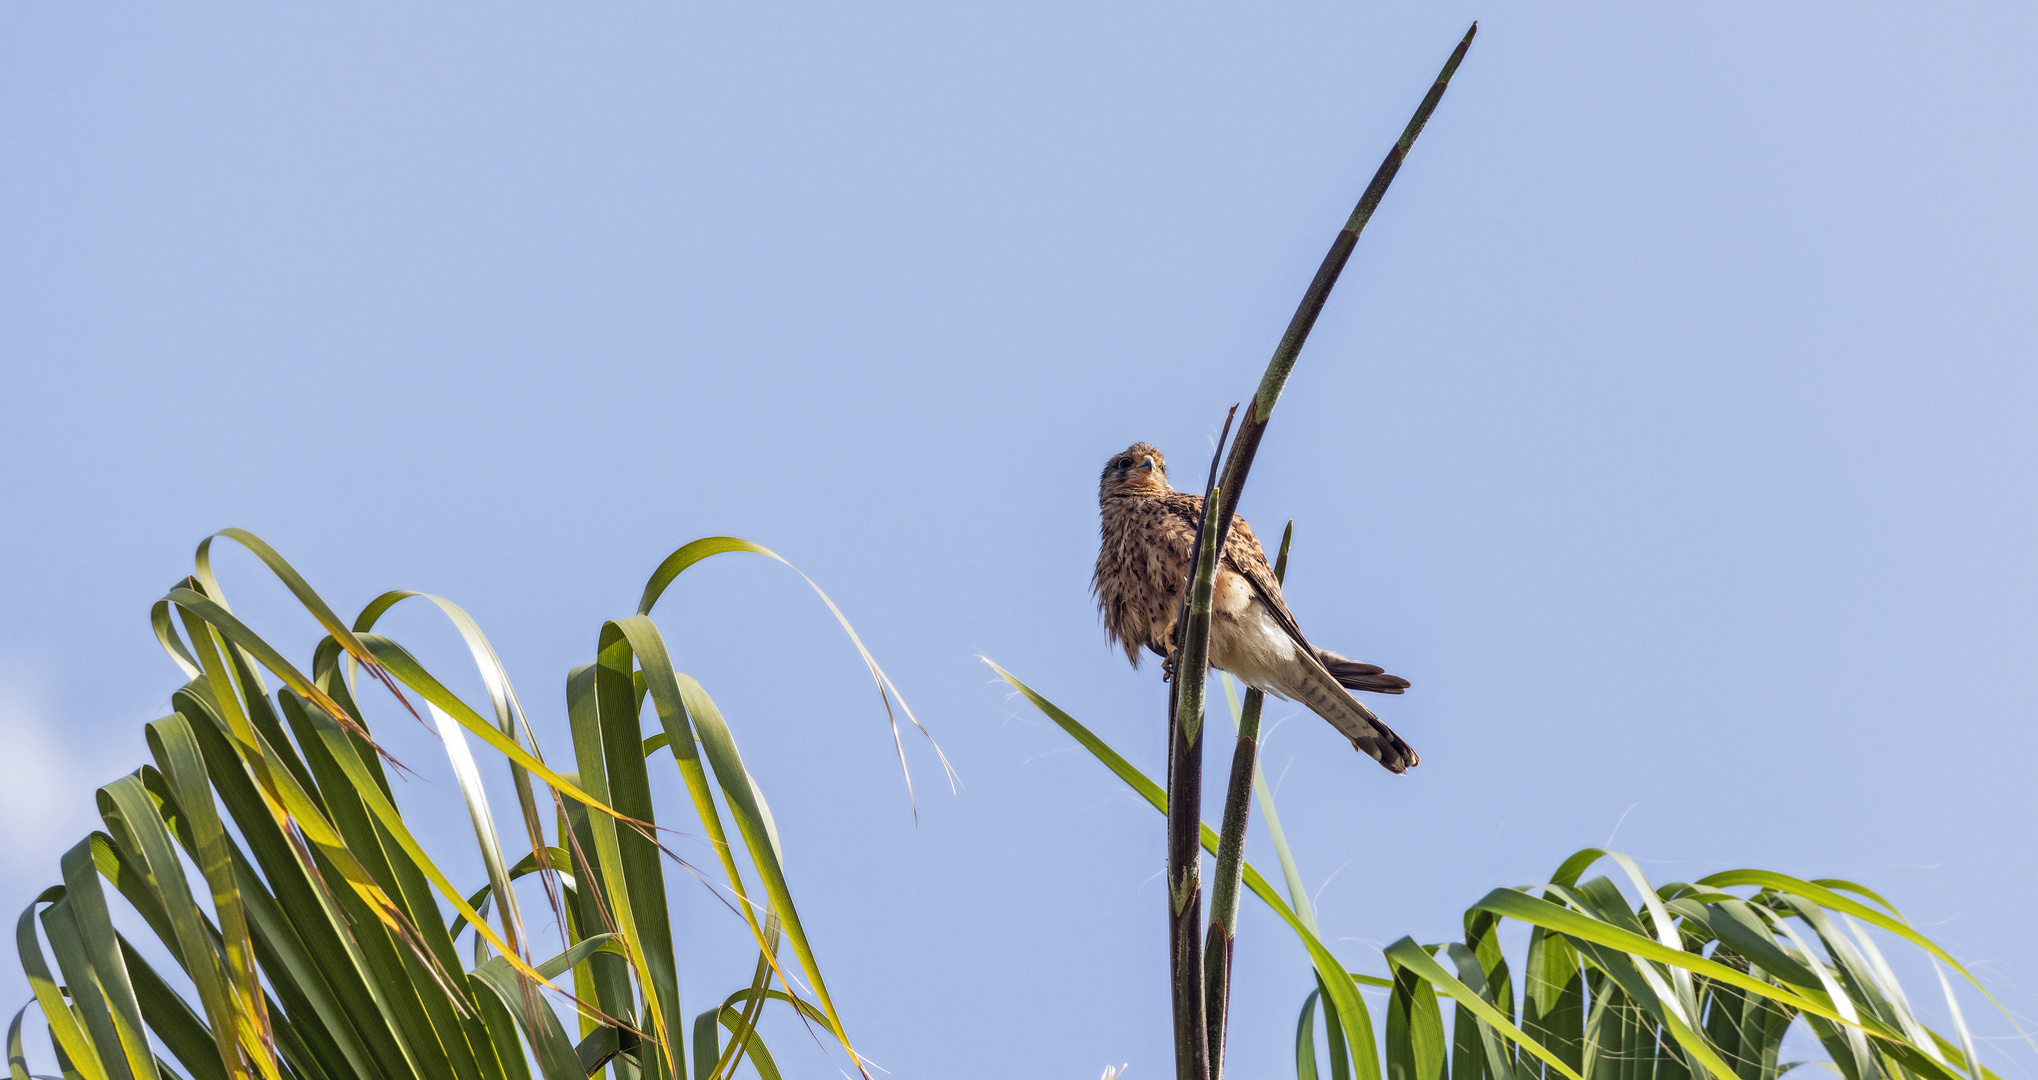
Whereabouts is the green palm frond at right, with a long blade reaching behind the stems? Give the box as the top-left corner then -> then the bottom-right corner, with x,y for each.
986,660 -> 1995,1080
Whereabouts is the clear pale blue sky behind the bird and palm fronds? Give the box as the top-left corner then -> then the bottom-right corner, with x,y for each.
0,2 -> 2038,1078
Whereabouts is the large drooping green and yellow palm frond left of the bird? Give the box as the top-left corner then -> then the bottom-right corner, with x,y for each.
8,530 -> 917,1080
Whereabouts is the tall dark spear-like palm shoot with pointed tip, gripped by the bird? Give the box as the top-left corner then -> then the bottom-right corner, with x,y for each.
1170,22 -> 1480,1080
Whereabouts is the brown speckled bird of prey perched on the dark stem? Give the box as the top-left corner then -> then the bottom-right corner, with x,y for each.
1090,442 -> 1423,772
